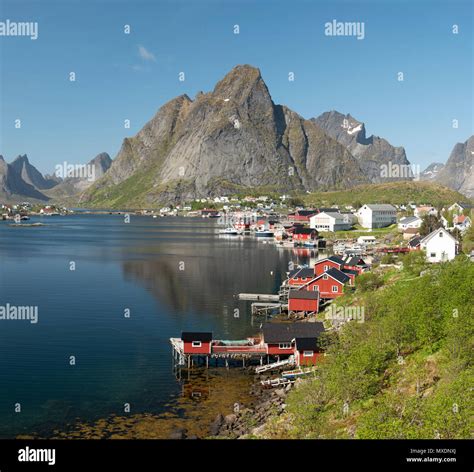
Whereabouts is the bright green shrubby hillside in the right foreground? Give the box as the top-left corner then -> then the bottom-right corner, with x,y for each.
264,253 -> 474,439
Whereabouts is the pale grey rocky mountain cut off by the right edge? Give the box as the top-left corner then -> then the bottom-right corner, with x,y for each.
436,136 -> 474,197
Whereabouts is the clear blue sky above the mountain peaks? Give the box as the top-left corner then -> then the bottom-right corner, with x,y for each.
0,0 -> 473,173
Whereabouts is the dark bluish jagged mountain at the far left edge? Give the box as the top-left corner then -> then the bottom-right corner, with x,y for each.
0,156 -> 48,202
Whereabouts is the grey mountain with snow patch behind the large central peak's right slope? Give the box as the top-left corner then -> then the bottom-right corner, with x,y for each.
311,111 -> 410,183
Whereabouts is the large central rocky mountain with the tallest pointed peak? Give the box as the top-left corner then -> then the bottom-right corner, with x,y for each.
83,65 -> 369,206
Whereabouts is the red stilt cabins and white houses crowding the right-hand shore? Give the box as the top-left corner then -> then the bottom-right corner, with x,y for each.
158,196 -> 473,437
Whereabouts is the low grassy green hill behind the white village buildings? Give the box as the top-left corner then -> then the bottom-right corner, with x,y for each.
304,182 -> 469,207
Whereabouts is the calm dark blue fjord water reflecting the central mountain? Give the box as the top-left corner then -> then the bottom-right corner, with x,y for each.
0,214 -> 318,437
